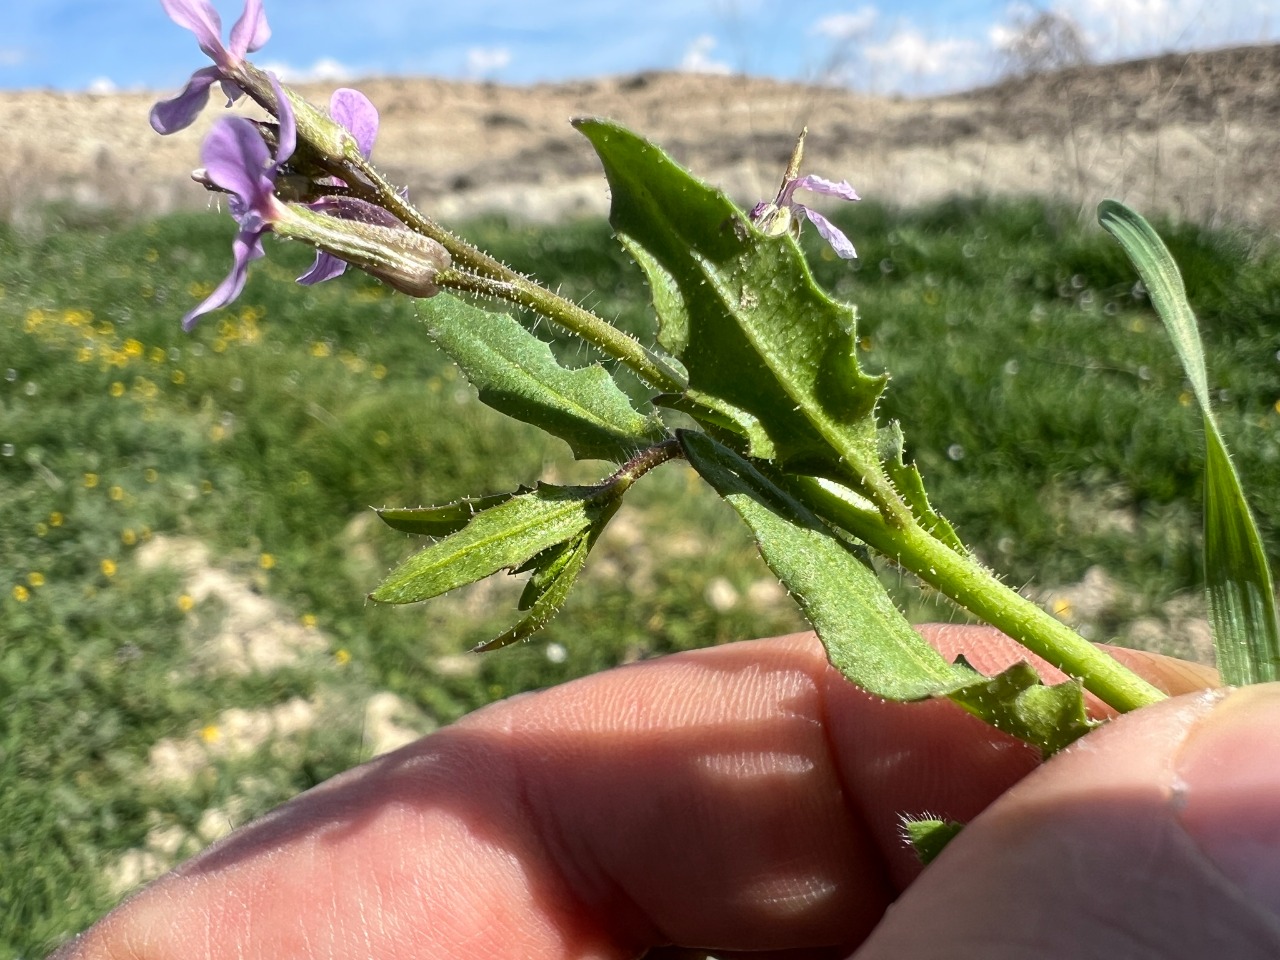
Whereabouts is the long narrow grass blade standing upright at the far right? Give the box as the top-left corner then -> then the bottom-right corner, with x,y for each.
1098,200 -> 1280,685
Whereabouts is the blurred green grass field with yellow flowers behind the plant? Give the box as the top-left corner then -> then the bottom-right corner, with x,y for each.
0,201 -> 1280,957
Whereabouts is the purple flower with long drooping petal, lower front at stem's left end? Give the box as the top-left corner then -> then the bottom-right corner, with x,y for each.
182,76 -> 297,330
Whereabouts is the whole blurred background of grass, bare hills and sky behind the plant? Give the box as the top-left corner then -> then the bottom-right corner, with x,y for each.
0,0 -> 1280,957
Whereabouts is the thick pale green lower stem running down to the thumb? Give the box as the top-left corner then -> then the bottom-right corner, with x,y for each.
796,477 -> 1165,713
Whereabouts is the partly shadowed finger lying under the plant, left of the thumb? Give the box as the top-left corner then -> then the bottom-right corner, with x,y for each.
49,631 -> 1208,959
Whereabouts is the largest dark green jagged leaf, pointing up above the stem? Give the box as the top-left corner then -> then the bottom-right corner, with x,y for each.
575,119 -> 884,476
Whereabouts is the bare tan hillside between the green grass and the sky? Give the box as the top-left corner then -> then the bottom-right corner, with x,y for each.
0,46 -> 1280,229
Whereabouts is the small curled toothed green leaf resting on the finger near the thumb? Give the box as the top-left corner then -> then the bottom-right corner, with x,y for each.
947,660 -> 1098,756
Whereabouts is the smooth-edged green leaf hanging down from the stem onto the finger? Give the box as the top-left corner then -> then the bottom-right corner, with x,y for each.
678,430 -> 975,700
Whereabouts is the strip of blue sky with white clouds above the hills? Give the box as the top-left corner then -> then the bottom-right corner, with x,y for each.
0,0 -> 1280,93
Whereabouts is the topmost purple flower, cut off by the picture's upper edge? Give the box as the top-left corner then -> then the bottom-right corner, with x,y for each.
151,0 -> 271,133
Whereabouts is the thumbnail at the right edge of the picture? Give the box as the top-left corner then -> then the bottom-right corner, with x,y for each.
1176,684 -> 1280,916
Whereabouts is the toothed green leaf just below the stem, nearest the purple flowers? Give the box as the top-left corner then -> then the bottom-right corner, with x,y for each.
417,293 -> 667,463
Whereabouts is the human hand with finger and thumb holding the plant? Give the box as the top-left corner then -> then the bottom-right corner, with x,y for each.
58,627 -> 1280,960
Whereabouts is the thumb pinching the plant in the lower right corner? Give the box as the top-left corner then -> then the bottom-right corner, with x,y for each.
856,684 -> 1280,960
